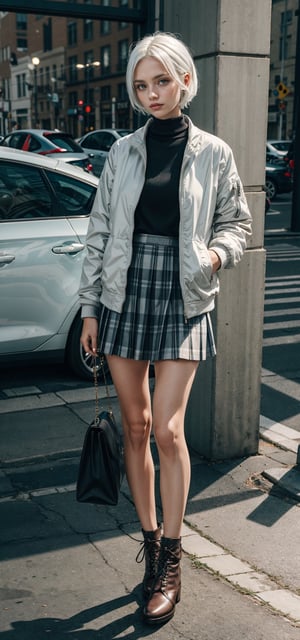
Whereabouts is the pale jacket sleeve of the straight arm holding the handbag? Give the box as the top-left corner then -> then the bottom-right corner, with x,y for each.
79,148 -> 115,318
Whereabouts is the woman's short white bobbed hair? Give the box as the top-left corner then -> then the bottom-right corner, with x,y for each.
126,31 -> 198,113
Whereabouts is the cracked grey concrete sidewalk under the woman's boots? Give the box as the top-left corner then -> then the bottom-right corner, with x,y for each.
0,387 -> 300,640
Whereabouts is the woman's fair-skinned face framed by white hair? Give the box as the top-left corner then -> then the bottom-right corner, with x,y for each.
133,56 -> 188,120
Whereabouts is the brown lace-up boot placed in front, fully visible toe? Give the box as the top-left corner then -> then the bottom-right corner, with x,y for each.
144,537 -> 181,624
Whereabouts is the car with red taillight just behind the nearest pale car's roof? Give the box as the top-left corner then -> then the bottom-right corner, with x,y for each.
0,129 -> 93,172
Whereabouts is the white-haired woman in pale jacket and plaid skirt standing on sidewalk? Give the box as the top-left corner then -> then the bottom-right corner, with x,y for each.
80,33 -> 251,624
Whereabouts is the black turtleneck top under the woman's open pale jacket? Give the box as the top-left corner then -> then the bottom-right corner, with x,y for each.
134,115 -> 188,237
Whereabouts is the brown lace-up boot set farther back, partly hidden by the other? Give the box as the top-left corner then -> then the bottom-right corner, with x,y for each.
136,525 -> 161,598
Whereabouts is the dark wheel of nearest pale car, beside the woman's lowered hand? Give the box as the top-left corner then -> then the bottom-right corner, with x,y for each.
66,315 -> 109,380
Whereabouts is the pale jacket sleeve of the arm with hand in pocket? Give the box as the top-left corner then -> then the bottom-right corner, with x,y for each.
209,145 -> 252,269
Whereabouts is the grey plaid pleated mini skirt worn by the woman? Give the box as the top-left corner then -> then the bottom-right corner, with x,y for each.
99,234 -> 216,362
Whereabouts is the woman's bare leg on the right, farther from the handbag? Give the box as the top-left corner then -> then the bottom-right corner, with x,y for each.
153,360 -> 198,538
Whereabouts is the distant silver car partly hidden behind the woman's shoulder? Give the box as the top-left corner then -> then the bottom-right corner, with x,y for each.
76,129 -> 132,176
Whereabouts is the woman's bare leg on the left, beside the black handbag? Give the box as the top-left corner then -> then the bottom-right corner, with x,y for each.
106,356 -> 157,531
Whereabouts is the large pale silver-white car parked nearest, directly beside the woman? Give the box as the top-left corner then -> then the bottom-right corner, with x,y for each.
0,146 -> 98,379
